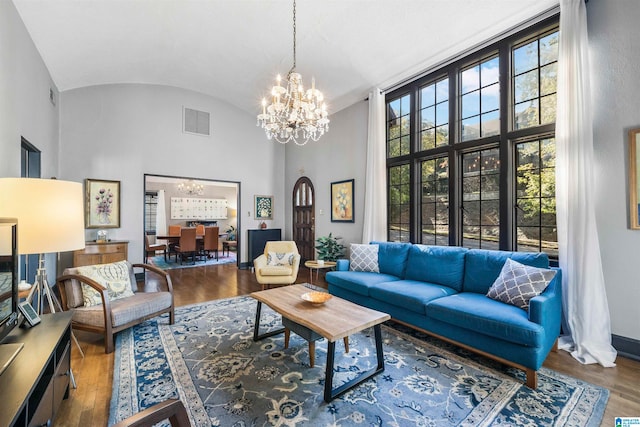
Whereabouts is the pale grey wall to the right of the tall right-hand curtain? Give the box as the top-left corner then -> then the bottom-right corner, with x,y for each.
587,0 -> 640,340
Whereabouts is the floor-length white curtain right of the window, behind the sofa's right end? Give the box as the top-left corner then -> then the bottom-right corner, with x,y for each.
556,0 -> 616,367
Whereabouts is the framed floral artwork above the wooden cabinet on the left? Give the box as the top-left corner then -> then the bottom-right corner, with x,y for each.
84,179 -> 120,228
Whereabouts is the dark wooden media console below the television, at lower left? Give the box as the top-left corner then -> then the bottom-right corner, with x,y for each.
0,312 -> 72,427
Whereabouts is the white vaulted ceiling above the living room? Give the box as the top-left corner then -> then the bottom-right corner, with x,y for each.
13,0 -> 558,114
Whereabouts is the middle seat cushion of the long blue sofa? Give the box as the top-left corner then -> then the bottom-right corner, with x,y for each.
369,280 -> 456,314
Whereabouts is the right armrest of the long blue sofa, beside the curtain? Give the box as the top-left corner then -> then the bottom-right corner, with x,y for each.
529,267 -> 562,340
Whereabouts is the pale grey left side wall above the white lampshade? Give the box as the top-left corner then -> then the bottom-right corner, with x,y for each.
0,1 -> 58,178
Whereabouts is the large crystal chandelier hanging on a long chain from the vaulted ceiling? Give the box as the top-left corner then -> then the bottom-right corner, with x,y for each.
257,0 -> 329,145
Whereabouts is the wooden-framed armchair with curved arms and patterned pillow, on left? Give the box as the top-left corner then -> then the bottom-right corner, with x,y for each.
57,261 -> 174,353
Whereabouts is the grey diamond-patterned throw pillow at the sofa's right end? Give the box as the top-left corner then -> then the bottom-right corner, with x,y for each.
487,258 -> 556,310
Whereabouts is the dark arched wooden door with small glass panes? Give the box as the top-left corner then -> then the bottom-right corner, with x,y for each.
293,176 -> 316,263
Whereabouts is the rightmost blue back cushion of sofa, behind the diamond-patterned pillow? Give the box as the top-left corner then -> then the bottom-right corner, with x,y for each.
462,249 -> 549,295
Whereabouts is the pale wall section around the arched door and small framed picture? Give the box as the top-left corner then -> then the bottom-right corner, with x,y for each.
284,101 -> 369,256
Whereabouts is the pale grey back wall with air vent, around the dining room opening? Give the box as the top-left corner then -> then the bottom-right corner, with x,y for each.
60,84 -> 285,262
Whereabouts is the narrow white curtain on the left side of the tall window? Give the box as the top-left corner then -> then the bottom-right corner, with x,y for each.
362,88 -> 387,244
